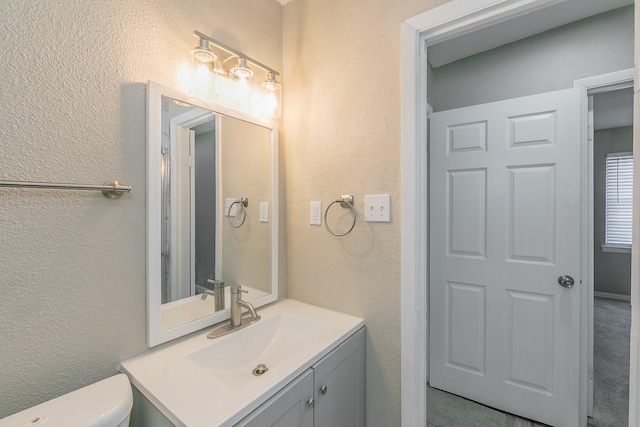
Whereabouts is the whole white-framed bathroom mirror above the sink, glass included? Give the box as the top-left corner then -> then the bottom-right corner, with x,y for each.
147,82 -> 278,347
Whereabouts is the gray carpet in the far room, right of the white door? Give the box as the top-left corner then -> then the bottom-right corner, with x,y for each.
589,298 -> 631,427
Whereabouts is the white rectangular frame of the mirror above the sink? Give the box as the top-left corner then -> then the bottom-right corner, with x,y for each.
146,81 -> 279,347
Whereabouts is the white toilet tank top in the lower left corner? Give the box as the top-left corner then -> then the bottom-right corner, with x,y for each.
0,374 -> 133,427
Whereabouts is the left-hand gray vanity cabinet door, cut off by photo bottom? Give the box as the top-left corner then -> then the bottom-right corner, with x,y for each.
236,369 -> 313,427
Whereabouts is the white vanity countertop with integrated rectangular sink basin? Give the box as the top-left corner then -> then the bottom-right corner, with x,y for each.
121,300 -> 364,427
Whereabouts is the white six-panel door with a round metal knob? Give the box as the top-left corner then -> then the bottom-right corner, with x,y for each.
429,89 -> 581,427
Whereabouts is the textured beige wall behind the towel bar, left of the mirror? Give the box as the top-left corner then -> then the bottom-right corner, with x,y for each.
0,0 -> 282,418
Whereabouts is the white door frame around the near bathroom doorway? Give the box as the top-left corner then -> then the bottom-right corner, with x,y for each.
401,0 -> 640,427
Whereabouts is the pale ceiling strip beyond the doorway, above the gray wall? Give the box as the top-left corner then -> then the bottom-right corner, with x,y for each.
427,0 -> 633,68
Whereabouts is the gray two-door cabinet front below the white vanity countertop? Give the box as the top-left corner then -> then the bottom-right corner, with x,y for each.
235,328 -> 365,427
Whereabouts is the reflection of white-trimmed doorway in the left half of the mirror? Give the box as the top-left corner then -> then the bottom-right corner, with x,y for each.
161,96 -> 217,304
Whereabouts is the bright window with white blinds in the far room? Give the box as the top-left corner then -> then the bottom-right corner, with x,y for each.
602,153 -> 633,250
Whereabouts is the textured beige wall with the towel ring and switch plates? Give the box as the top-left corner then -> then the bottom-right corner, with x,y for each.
283,0 -> 443,427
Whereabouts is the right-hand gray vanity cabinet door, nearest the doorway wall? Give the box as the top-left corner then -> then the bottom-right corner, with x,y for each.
313,328 -> 365,427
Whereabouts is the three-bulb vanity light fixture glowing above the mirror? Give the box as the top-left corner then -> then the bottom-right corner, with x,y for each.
189,31 -> 282,118
